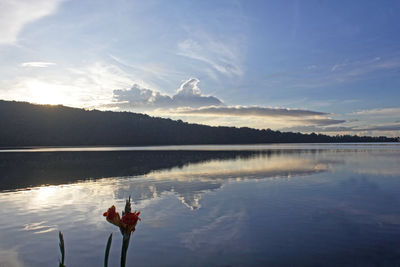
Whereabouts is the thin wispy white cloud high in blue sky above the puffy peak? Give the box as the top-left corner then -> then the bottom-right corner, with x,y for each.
177,33 -> 243,78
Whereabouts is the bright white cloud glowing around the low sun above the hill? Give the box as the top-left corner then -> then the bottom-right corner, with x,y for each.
0,62 -> 136,108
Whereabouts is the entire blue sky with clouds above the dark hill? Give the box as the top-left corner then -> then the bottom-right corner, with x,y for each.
0,0 -> 400,136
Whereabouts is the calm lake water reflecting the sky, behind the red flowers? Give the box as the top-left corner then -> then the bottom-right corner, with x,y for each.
0,144 -> 400,267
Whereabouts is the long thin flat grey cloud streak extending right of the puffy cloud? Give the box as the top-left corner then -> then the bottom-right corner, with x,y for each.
178,107 -> 330,118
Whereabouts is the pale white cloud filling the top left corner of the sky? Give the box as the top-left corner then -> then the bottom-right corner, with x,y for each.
0,0 -> 62,44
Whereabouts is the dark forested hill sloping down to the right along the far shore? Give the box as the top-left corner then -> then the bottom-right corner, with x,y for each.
0,100 -> 398,147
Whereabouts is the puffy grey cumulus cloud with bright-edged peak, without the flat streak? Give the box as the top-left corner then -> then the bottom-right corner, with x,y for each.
111,78 -> 223,109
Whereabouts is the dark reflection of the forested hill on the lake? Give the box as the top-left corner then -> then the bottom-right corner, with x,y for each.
0,150 -> 330,190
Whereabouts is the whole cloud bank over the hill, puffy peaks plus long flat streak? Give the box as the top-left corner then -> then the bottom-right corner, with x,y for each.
108,78 -> 346,132
